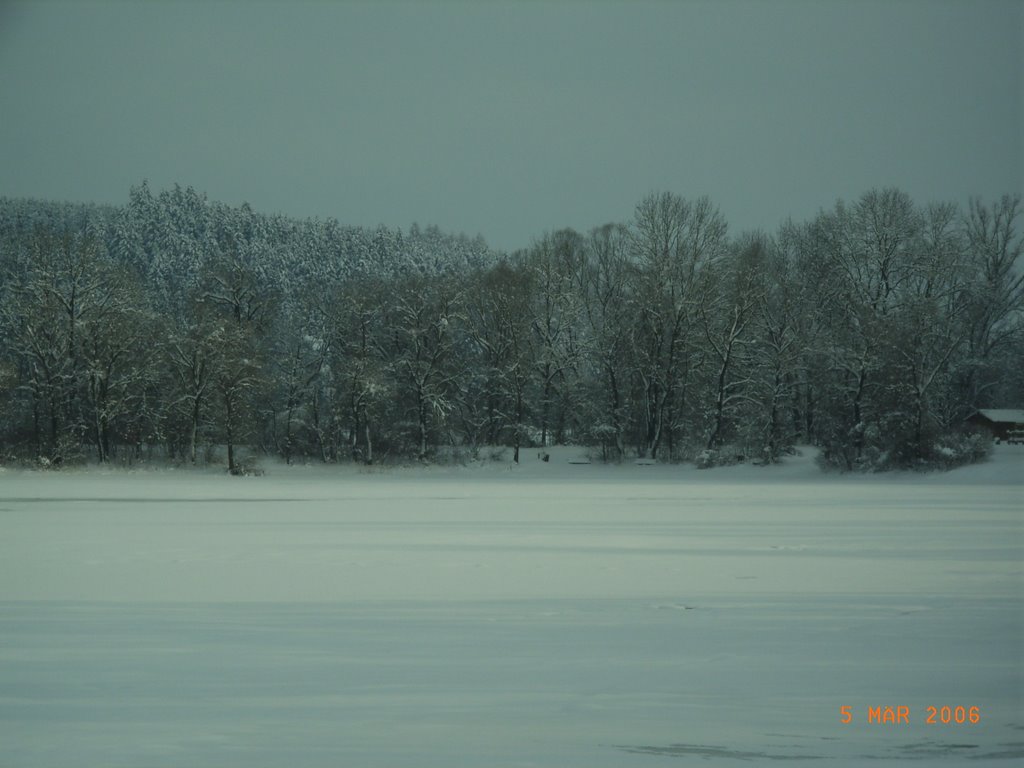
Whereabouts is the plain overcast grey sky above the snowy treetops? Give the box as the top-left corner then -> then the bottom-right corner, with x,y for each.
0,0 -> 1024,249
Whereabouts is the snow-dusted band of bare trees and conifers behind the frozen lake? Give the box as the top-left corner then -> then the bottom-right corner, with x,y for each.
0,183 -> 1024,472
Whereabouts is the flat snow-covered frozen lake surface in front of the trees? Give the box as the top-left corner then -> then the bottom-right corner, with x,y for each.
0,446 -> 1024,768
